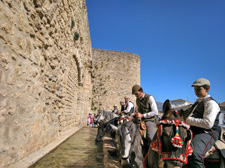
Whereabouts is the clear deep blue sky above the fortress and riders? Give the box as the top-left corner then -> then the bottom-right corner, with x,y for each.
86,0 -> 225,103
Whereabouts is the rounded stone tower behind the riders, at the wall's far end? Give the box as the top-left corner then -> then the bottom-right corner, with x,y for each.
92,49 -> 140,111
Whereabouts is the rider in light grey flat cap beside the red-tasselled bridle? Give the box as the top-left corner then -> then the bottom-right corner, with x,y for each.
186,78 -> 220,168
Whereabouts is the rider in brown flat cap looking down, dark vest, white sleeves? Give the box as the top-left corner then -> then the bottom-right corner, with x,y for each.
132,85 -> 158,144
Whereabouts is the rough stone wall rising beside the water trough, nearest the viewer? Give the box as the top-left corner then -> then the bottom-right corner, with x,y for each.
0,0 -> 92,167
